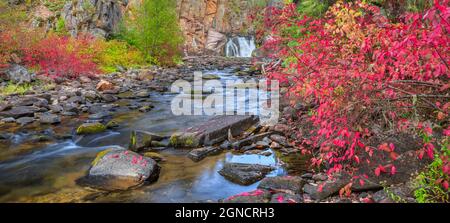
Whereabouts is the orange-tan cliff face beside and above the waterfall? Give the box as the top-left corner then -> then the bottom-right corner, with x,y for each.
177,0 -> 255,53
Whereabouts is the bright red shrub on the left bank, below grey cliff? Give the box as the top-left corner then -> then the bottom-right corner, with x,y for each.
24,35 -> 98,78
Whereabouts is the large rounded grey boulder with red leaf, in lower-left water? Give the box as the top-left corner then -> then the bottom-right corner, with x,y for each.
77,149 -> 160,191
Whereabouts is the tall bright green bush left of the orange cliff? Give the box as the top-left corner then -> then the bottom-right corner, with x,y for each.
118,0 -> 183,65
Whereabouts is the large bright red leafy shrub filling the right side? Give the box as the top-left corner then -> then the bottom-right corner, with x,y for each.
256,0 -> 450,179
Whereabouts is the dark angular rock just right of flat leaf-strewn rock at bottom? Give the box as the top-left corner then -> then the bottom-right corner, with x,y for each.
303,178 -> 349,200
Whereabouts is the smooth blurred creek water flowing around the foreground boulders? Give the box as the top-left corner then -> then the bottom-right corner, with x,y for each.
0,67 -> 305,202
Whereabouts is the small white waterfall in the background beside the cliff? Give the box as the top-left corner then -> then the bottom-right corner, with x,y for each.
225,37 -> 256,57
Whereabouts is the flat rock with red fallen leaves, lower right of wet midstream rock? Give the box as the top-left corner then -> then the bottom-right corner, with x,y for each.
258,176 -> 305,194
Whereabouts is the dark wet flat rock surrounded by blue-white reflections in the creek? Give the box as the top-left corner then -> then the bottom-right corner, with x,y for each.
219,163 -> 275,185
